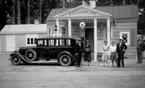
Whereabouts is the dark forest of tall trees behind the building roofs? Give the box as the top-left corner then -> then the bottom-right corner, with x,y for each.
0,0 -> 140,28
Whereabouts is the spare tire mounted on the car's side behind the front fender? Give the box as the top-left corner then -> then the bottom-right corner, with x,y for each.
25,49 -> 37,62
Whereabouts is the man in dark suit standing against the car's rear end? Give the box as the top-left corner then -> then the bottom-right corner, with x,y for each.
75,38 -> 82,67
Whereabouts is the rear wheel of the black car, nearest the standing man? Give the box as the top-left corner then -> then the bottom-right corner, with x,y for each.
59,54 -> 72,66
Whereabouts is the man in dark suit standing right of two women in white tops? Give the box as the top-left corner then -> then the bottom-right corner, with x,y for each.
116,39 -> 127,67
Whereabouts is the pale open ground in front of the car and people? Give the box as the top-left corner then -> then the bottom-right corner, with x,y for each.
0,53 -> 145,88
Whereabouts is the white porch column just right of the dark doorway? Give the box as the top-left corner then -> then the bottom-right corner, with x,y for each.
94,18 -> 98,62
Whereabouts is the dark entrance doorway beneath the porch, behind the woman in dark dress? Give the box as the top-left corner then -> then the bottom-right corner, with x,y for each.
85,28 -> 94,53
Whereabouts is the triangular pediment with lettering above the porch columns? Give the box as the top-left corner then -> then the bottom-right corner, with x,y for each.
54,5 -> 112,18
